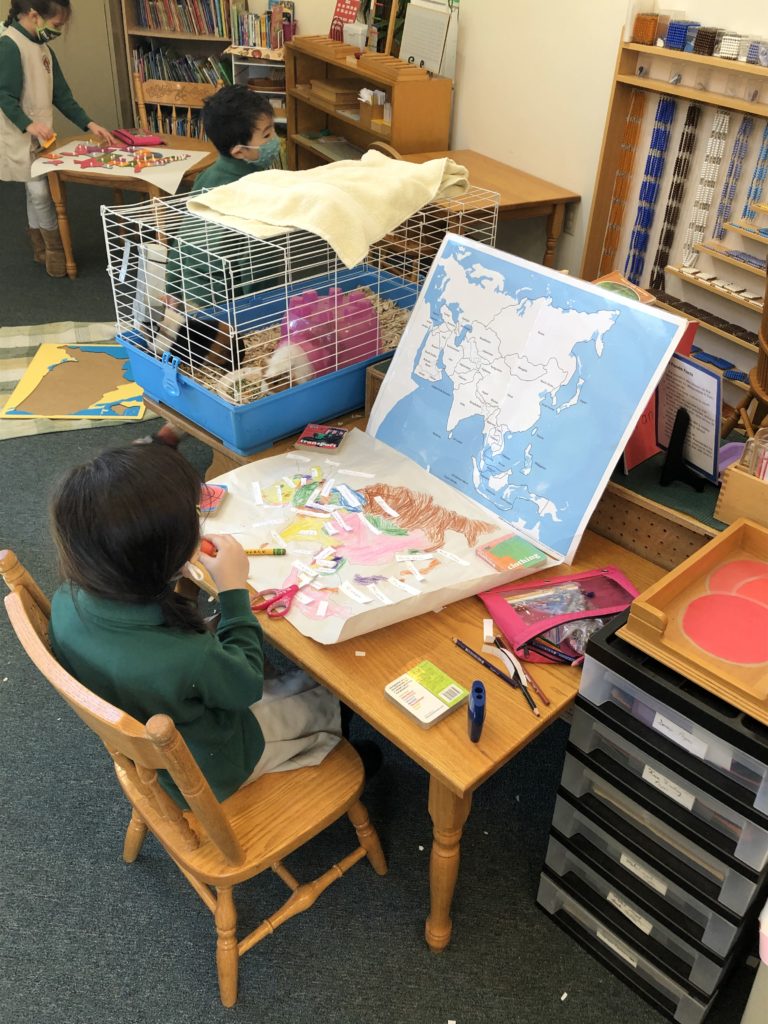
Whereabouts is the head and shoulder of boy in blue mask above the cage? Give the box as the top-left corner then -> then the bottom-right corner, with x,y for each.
195,85 -> 280,191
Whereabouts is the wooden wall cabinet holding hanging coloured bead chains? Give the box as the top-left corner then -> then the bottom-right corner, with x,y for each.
582,42 -> 768,401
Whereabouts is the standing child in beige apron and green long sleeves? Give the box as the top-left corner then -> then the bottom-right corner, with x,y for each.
0,0 -> 115,278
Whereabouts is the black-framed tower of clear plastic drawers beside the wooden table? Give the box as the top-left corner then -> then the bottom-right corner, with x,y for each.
539,614 -> 768,1024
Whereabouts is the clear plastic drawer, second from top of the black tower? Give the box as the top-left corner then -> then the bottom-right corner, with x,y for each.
570,697 -> 768,871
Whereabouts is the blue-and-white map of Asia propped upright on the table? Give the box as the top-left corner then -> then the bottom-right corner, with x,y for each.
368,234 -> 686,561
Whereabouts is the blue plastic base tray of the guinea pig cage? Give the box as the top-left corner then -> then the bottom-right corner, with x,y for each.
117,268 -> 418,456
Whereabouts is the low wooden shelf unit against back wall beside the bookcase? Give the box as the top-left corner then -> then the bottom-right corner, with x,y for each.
286,36 -> 453,170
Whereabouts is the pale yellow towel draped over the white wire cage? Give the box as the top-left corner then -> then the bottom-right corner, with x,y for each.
187,151 -> 469,267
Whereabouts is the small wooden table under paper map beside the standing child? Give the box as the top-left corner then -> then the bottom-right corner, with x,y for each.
48,132 -> 218,278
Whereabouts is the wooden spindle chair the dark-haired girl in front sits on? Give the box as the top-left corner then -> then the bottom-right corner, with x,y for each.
0,551 -> 387,1007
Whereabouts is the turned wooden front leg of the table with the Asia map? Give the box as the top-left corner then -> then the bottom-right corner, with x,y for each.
424,775 -> 472,953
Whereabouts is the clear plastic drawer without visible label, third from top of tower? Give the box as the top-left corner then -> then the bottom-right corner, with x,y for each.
561,744 -> 765,914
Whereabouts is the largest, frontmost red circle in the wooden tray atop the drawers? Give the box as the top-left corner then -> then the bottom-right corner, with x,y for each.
682,593 -> 768,665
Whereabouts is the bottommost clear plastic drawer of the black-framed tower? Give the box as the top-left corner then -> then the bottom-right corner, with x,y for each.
537,873 -> 712,1024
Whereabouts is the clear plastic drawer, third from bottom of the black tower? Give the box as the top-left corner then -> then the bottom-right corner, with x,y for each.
552,796 -> 745,958
